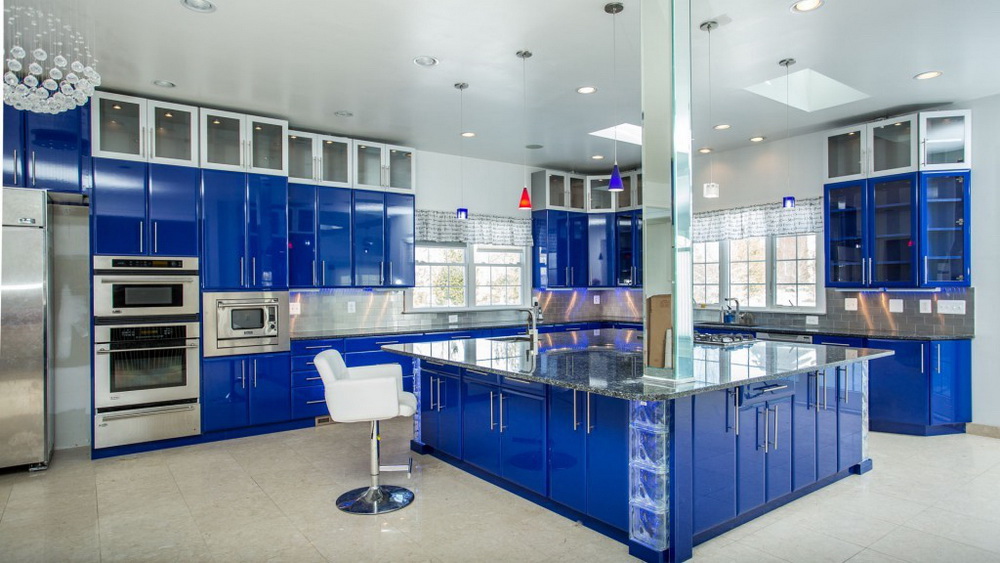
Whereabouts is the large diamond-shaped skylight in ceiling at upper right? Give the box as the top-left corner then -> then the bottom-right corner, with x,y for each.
746,68 -> 869,113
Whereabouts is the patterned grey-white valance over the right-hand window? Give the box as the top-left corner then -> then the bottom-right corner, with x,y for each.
691,197 -> 823,242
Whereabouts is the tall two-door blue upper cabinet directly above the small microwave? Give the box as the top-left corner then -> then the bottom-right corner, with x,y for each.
201,170 -> 288,291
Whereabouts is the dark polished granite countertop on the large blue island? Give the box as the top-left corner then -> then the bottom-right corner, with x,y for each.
382,329 -> 892,401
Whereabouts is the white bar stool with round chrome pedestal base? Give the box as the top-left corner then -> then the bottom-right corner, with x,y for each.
314,350 -> 417,514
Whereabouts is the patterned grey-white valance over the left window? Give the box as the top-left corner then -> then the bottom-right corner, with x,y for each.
416,209 -> 531,246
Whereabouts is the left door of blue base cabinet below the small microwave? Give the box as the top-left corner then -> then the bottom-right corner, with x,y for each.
201,356 -> 250,432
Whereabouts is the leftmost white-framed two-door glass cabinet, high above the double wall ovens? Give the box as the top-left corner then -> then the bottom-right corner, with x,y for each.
91,92 -> 198,166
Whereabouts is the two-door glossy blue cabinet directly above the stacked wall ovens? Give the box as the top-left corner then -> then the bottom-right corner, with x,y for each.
91,158 -> 201,256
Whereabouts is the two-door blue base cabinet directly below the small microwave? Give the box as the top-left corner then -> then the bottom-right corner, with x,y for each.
201,353 -> 292,432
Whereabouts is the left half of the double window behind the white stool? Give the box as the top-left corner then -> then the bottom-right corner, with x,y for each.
412,245 -> 467,309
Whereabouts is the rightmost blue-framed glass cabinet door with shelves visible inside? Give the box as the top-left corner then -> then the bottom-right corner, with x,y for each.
920,171 -> 972,287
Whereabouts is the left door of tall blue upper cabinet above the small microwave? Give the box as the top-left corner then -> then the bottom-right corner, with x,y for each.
201,170 -> 247,290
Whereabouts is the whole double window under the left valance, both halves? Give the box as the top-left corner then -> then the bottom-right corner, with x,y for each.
406,244 -> 528,310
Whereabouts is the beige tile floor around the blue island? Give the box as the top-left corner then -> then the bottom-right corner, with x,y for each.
0,420 -> 1000,563
